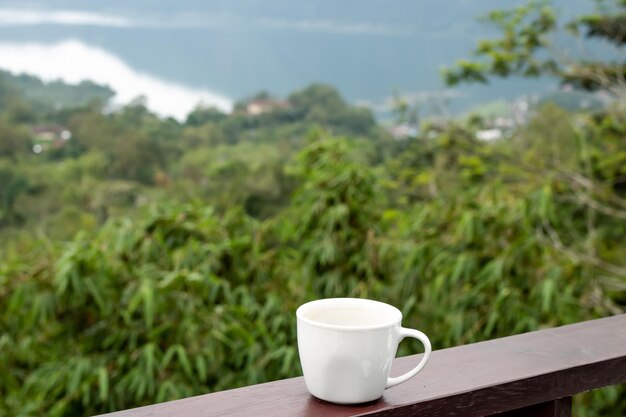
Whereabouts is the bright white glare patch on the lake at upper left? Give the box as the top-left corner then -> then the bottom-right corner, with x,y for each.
0,40 -> 232,120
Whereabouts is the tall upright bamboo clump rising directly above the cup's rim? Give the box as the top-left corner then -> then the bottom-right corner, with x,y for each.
286,133 -> 382,298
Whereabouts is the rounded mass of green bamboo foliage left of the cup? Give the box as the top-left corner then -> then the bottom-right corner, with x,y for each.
0,207 -> 295,415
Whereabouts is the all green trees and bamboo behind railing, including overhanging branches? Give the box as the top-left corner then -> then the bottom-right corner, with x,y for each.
0,1 -> 626,417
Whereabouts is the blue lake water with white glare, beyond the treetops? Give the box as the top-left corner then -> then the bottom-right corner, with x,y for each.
0,0 -> 584,118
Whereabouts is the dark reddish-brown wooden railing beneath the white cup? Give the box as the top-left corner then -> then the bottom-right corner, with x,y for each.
98,315 -> 626,417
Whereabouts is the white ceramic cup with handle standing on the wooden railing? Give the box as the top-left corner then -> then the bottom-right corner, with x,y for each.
296,298 -> 431,404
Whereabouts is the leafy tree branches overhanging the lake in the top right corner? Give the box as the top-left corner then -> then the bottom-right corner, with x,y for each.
442,0 -> 626,91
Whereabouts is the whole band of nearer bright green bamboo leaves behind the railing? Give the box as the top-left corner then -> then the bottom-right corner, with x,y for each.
0,123 -> 624,416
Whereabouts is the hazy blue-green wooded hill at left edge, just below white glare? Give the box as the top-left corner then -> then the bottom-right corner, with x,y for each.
0,70 -> 115,109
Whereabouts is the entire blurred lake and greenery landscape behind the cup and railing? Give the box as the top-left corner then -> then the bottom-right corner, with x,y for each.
0,0 -> 626,417
